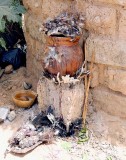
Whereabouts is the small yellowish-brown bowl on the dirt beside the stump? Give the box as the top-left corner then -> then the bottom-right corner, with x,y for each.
12,90 -> 37,108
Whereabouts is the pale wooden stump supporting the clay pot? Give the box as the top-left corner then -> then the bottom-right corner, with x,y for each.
37,76 -> 84,127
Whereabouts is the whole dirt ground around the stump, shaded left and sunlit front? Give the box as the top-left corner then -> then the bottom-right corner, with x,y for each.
0,68 -> 126,160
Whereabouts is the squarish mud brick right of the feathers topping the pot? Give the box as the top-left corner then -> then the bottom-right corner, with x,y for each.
86,5 -> 116,36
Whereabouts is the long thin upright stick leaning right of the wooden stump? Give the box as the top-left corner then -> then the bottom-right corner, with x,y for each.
82,52 -> 94,127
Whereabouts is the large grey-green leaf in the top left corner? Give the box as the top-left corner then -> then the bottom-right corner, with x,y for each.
0,0 -> 25,32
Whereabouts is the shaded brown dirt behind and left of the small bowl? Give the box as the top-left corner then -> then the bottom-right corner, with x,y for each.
0,67 -> 35,106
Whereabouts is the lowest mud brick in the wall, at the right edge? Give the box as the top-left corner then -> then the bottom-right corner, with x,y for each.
92,86 -> 126,118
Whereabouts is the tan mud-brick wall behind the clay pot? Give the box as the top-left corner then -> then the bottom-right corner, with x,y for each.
24,0 -> 126,118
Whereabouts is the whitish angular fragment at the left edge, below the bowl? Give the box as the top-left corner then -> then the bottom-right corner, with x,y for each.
0,107 -> 10,122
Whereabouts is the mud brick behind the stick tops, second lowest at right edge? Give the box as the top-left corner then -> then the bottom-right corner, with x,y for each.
91,64 -> 126,95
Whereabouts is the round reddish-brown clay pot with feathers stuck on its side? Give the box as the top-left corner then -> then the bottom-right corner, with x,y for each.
44,36 -> 84,76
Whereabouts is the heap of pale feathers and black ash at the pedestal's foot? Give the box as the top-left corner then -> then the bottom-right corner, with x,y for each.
8,106 -> 81,153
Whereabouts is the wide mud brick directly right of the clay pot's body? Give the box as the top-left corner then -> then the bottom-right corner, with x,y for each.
86,36 -> 126,67
